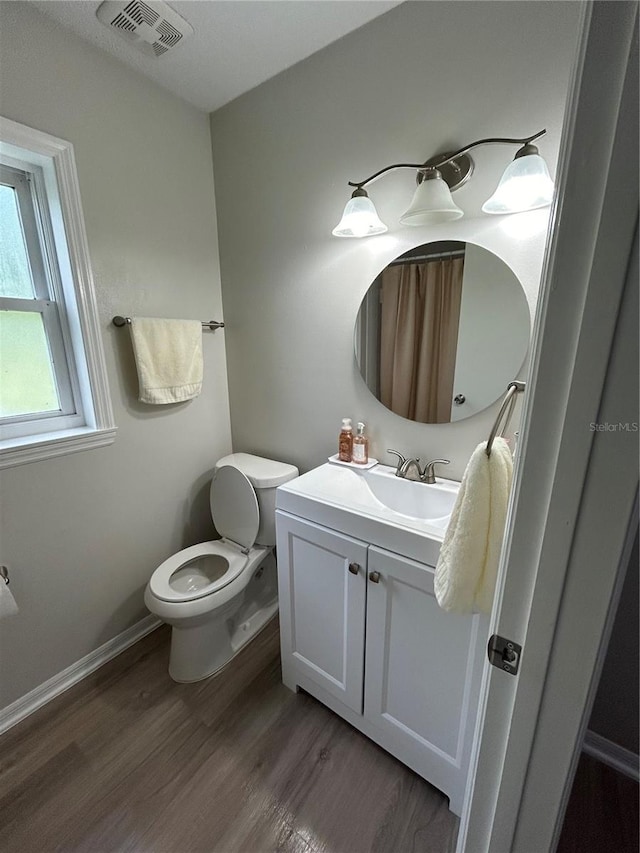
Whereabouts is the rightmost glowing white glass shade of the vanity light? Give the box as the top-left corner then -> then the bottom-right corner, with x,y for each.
482,154 -> 553,213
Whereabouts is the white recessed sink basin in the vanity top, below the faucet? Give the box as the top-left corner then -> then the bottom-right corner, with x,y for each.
364,465 -> 459,528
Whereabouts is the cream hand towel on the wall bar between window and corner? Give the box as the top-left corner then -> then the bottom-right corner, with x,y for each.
131,317 -> 202,404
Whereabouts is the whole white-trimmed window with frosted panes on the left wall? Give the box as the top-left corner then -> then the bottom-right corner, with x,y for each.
0,119 -> 115,467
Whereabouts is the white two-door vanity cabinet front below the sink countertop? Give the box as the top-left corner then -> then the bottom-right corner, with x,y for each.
276,510 -> 486,815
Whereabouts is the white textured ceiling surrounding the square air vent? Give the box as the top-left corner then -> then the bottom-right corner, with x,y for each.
31,0 -> 400,112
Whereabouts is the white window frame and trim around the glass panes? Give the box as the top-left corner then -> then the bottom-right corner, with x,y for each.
0,116 -> 116,468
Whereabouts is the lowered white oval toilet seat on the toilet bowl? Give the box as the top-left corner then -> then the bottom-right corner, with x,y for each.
149,539 -> 248,602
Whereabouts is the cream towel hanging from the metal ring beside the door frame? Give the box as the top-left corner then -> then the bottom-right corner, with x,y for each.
434,438 -> 513,613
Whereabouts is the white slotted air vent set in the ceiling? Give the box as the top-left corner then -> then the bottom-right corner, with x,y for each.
96,0 -> 193,56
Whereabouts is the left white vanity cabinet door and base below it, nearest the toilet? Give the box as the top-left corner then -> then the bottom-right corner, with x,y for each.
276,510 -> 367,713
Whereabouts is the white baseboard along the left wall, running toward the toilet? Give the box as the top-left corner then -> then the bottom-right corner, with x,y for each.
0,616 -> 162,734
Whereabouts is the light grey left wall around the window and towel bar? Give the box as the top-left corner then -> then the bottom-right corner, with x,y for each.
0,3 -> 231,707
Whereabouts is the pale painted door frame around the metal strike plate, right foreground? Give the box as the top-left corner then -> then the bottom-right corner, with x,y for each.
457,0 -> 638,853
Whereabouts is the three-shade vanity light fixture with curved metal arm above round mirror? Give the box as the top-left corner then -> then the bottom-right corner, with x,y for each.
332,129 -> 553,237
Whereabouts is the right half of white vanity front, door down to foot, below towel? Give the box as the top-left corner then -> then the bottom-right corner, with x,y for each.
364,546 -> 486,814
